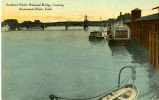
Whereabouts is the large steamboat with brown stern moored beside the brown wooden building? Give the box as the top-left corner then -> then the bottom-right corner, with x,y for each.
107,22 -> 130,46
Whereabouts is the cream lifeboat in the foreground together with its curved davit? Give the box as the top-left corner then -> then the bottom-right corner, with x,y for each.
98,66 -> 139,100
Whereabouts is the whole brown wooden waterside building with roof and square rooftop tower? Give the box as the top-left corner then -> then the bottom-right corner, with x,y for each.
125,7 -> 159,70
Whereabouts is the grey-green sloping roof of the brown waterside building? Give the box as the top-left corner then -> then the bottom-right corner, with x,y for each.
135,13 -> 159,21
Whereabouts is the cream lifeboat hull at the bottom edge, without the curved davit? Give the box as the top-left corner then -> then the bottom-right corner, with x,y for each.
99,84 -> 139,100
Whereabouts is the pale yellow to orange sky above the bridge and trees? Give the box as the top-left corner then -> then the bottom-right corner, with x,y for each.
1,0 -> 159,22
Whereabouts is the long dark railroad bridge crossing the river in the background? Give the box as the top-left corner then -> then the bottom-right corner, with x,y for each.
18,15 -> 107,30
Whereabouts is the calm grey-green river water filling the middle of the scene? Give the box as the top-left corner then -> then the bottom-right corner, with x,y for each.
2,27 -> 159,100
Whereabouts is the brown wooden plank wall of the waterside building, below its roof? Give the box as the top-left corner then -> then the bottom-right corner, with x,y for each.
126,19 -> 159,70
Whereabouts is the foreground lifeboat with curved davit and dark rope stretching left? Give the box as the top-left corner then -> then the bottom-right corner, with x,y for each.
49,66 -> 139,100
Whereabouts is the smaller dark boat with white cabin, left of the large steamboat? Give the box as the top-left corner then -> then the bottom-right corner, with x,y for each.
89,28 -> 107,39
